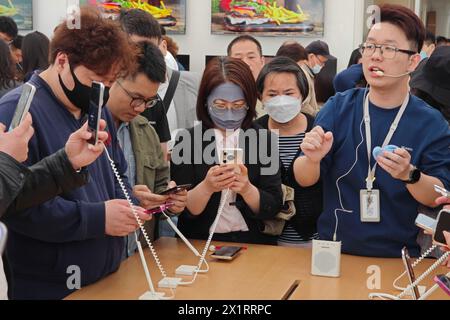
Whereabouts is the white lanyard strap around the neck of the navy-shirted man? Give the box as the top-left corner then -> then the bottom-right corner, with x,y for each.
364,92 -> 409,191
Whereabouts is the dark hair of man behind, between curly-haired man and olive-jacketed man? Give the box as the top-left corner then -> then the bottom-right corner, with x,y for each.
119,9 -> 162,41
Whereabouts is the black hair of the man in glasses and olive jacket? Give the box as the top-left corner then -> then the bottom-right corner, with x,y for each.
131,41 -> 166,83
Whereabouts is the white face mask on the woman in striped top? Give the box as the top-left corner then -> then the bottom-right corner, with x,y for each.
264,96 -> 302,123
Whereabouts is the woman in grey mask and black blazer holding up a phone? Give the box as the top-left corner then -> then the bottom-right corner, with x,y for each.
171,58 -> 282,244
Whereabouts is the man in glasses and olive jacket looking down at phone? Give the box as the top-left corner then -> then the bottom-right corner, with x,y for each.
107,42 -> 187,259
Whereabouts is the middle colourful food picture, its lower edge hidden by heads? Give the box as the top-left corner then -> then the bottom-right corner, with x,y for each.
81,0 -> 186,34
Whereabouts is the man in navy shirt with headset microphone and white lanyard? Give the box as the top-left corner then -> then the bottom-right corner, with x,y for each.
294,5 -> 450,257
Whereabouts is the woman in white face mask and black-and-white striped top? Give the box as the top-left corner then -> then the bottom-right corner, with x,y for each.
256,57 -> 322,247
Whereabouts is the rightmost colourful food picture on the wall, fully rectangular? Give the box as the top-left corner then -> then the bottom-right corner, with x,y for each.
211,0 -> 325,37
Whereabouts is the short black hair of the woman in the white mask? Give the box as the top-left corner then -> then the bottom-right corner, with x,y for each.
256,56 -> 309,99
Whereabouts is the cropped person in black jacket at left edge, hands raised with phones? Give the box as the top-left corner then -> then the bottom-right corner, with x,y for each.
0,115 -> 108,299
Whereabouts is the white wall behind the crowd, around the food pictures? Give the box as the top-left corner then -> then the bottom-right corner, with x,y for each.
33,0 -> 366,72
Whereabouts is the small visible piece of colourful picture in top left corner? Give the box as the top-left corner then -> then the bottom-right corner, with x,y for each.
0,0 -> 33,30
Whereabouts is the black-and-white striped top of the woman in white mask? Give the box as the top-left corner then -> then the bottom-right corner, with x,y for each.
278,132 -> 318,244
